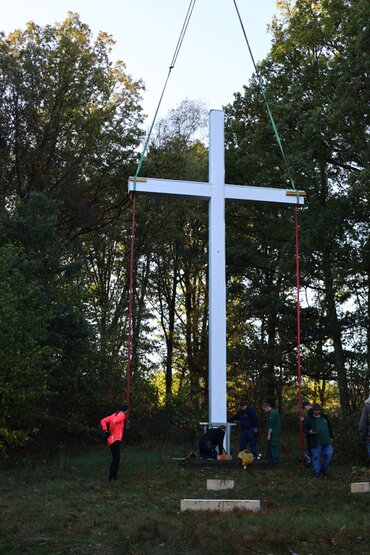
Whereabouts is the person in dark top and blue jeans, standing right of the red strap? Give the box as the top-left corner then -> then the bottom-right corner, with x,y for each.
304,403 -> 333,478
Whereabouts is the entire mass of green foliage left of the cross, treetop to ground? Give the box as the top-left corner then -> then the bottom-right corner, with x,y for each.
0,13 -> 147,456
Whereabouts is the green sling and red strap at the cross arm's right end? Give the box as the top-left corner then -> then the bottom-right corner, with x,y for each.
233,0 -> 304,465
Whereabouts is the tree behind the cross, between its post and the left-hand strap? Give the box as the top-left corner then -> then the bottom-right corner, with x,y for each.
139,100 -> 207,401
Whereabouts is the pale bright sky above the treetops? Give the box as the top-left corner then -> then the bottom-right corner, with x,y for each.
0,0 -> 278,123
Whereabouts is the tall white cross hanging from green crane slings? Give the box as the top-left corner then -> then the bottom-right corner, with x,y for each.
129,110 -> 305,432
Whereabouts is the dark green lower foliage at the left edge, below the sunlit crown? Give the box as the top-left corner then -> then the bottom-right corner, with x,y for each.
0,194 -> 98,449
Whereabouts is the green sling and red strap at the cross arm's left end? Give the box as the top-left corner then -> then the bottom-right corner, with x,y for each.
126,0 -> 196,410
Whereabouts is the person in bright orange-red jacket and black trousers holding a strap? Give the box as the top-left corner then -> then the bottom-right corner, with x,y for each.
100,403 -> 128,482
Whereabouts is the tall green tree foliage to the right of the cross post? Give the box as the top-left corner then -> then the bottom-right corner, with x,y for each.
227,0 -> 369,412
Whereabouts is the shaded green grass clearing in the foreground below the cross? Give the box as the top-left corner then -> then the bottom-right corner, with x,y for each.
0,445 -> 370,555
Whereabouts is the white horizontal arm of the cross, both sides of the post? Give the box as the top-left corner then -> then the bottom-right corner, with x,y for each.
129,177 -> 305,205
